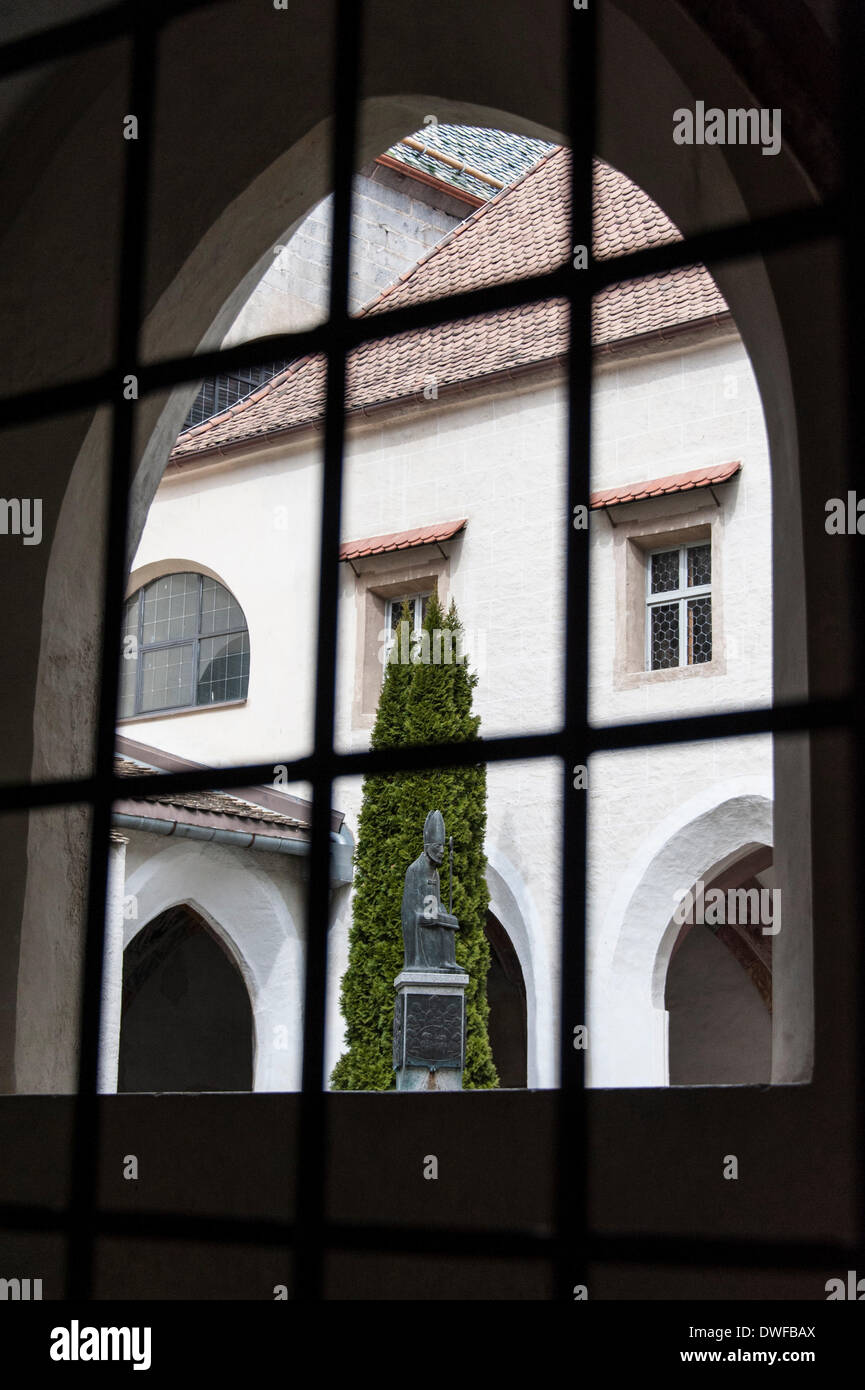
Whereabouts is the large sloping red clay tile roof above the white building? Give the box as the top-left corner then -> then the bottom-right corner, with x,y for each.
171,147 -> 729,463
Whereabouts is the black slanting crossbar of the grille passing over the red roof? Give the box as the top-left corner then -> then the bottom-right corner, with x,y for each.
0,200 -> 844,427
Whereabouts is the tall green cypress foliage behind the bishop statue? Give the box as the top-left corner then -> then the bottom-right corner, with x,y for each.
331,594 -> 498,1091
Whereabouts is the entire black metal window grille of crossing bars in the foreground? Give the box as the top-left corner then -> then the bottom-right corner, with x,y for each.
0,0 -> 865,1300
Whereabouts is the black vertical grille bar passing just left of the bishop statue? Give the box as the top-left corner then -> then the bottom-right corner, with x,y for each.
295,0 -> 363,1300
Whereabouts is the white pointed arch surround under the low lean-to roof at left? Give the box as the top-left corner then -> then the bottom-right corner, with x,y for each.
124,840 -> 305,1091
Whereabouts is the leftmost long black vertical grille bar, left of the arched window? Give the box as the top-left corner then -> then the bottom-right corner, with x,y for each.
67,0 -> 156,1300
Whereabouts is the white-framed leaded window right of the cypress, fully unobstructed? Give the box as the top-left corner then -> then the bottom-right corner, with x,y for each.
645,541 -> 712,671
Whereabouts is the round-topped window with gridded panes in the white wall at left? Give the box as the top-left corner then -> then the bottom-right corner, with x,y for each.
118,571 -> 249,719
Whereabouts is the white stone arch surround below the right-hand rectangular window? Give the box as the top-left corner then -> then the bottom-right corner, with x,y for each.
590,778 -> 783,1087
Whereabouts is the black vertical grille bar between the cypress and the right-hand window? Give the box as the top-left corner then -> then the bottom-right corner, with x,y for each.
555,3 -> 597,1300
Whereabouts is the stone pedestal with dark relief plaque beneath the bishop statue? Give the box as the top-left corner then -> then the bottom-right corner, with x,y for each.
394,970 -> 469,1091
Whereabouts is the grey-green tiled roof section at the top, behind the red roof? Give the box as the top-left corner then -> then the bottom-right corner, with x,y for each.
387,125 -> 552,202
